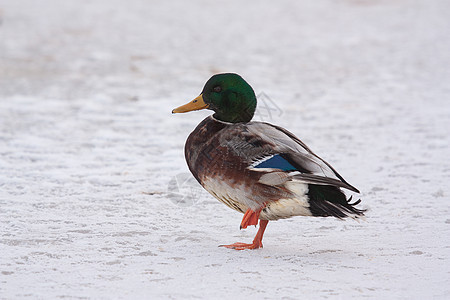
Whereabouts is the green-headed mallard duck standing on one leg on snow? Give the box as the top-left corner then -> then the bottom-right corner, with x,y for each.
172,73 -> 364,250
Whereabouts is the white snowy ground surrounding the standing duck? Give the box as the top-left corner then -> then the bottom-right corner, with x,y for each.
0,0 -> 450,299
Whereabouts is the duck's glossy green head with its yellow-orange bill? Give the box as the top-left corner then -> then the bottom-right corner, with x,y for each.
172,73 -> 256,123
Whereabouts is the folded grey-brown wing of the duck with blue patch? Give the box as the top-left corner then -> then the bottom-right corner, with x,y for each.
220,122 -> 359,193
